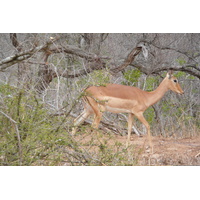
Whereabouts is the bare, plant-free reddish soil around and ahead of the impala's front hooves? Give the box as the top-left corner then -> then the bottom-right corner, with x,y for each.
116,135 -> 200,166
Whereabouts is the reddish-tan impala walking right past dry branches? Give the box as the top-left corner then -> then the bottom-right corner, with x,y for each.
73,71 -> 184,147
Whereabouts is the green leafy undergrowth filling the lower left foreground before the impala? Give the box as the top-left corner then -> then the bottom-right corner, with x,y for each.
0,85 -> 141,166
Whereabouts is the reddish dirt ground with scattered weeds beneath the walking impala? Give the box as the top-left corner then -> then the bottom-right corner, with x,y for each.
76,130 -> 200,166
